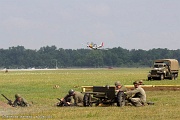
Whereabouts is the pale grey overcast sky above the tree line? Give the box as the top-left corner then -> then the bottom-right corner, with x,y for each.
0,0 -> 180,50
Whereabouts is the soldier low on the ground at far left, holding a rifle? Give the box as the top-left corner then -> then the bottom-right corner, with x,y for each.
12,94 -> 29,107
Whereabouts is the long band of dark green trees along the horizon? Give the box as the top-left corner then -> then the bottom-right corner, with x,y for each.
0,46 -> 180,69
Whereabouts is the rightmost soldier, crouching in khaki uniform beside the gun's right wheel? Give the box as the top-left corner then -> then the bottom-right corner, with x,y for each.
125,81 -> 146,107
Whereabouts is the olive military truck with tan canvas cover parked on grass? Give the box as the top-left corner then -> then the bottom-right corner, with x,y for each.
147,59 -> 179,80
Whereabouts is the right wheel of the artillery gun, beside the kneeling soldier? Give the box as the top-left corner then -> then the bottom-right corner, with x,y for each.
117,91 -> 125,107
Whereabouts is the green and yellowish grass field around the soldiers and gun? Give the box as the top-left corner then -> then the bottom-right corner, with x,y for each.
0,68 -> 180,120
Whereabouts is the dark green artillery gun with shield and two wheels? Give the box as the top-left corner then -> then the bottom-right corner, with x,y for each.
83,86 -> 126,107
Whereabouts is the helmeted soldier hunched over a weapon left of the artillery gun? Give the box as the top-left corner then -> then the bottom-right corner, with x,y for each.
57,89 -> 84,106
